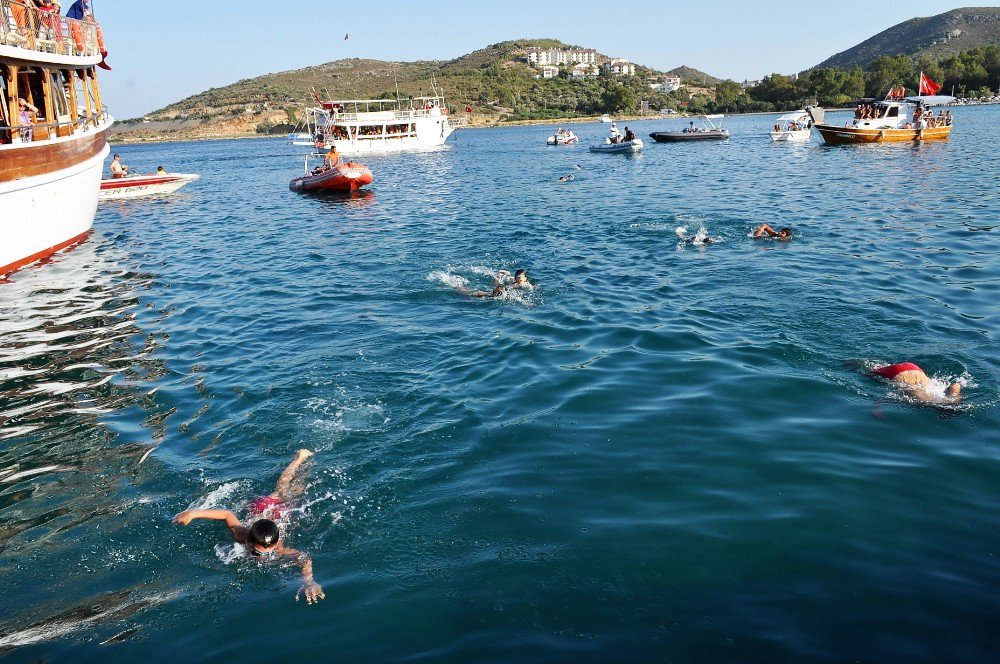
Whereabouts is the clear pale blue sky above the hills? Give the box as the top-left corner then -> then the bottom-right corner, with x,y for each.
92,0 -> 996,118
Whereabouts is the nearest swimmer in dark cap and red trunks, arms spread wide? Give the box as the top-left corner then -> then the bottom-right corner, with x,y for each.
174,450 -> 326,604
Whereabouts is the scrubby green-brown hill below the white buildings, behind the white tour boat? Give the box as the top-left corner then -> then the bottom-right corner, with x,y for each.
126,38 -> 718,126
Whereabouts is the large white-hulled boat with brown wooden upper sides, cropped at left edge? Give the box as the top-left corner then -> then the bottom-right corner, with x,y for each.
0,0 -> 112,277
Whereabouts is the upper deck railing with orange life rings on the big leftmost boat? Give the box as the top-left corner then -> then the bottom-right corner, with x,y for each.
0,0 -> 104,57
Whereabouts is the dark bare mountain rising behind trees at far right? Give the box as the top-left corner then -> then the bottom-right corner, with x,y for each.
817,7 -> 1000,69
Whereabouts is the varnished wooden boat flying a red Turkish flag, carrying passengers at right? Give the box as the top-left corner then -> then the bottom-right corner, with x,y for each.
808,72 -> 955,145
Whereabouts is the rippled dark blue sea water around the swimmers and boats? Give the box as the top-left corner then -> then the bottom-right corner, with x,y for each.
0,106 -> 1000,663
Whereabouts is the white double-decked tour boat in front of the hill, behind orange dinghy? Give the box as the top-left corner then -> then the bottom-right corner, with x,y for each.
292,96 -> 464,154
